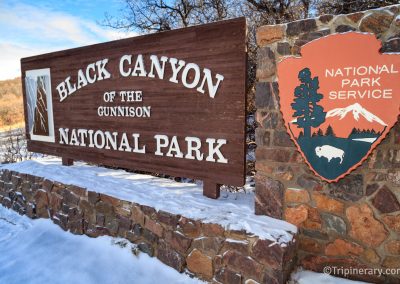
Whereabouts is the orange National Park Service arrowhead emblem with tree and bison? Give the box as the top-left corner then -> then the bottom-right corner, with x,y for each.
278,32 -> 400,182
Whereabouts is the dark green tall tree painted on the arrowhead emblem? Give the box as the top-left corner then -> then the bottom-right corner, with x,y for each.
291,68 -> 326,138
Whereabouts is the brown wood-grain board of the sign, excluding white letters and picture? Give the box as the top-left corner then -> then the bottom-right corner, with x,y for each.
21,18 -> 247,186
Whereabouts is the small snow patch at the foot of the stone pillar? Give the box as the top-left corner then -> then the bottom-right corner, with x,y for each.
288,269 -> 367,284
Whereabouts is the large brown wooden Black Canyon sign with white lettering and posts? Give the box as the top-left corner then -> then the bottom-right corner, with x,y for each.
21,18 -> 246,197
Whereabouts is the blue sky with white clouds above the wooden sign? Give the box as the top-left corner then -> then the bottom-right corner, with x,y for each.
0,0 -> 136,80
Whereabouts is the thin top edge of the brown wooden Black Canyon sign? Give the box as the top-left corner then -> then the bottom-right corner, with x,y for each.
21,17 -> 247,63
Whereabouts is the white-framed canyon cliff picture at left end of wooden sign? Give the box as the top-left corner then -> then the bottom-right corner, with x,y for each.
25,69 -> 54,142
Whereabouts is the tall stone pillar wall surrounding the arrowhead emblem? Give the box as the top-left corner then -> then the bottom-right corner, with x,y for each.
256,5 -> 400,283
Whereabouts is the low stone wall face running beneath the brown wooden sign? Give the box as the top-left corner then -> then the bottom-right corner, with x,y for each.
0,170 -> 295,284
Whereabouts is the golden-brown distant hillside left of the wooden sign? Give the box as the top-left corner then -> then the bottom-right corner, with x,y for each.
0,78 -> 24,131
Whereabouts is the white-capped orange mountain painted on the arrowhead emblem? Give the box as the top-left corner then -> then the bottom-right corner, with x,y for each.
319,103 -> 387,137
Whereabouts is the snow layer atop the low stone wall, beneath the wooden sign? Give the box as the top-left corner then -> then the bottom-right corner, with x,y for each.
0,157 -> 297,246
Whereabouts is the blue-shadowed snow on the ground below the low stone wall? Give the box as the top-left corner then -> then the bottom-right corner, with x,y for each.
0,206 -> 204,284
